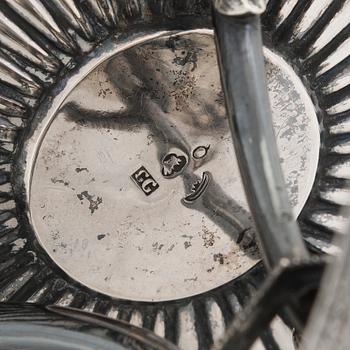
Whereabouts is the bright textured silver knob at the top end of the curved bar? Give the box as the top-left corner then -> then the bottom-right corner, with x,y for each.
213,0 -> 266,16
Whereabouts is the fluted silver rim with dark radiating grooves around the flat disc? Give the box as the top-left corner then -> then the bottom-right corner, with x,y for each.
0,0 -> 350,349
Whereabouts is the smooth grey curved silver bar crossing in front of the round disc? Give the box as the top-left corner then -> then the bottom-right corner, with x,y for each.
214,10 -> 308,267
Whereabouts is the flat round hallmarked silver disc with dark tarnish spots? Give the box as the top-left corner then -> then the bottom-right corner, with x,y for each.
25,30 -> 320,301
